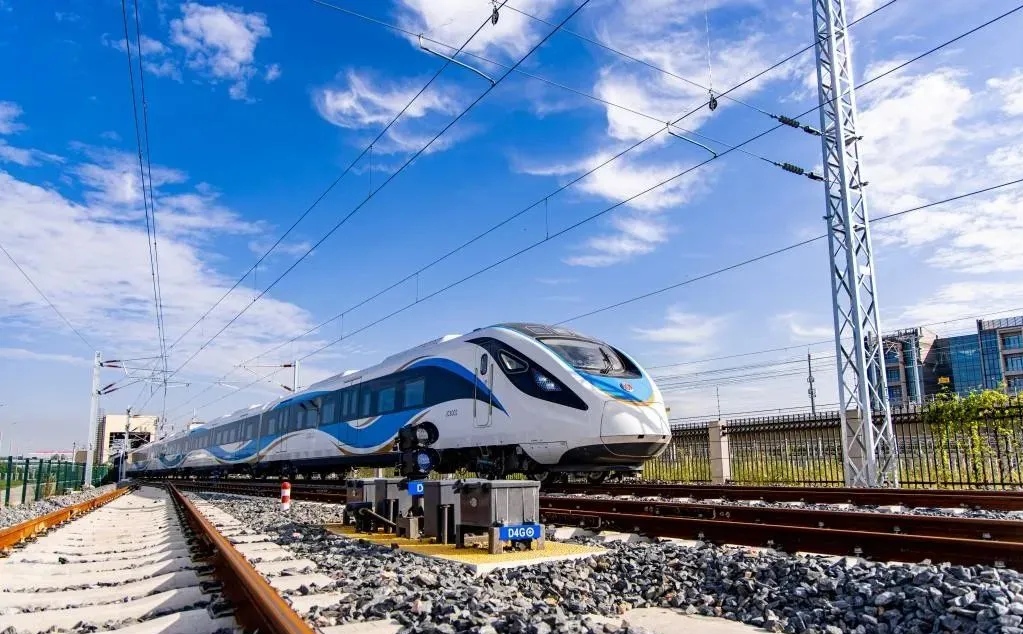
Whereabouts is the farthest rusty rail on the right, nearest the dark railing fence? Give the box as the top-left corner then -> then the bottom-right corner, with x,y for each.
543,483 -> 1023,510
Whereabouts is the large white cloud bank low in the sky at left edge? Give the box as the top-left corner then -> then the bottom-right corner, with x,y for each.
0,143 -> 347,419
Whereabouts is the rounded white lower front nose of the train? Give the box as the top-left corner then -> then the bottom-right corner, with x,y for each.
601,401 -> 671,459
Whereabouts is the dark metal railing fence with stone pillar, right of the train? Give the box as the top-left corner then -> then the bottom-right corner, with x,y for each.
643,400 -> 1023,489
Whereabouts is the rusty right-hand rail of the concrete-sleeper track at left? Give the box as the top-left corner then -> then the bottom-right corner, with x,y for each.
167,484 -> 314,634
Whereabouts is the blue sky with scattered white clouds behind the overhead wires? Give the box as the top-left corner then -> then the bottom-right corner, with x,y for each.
0,0 -> 1023,452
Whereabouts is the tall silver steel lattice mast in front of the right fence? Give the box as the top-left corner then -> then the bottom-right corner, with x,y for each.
811,0 -> 898,487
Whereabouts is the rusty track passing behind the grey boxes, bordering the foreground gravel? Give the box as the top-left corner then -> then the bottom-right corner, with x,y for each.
171,481 -> 1023,570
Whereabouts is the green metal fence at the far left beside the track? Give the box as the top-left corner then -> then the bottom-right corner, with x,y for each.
0,456 -> 108,506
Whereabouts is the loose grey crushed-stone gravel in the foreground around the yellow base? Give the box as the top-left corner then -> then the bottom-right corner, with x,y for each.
190,494 -> 1023,634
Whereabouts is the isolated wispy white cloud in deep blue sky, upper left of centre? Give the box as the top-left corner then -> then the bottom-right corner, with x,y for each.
313,69 -> 472,153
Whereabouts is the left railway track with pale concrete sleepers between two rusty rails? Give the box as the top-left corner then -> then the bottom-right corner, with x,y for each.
0,486 -> 313,634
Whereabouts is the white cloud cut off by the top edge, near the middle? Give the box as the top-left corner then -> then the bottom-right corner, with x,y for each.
399,0 -> 564,57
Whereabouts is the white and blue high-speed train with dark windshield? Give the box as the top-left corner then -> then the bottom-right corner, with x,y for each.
128,323 -> 671,482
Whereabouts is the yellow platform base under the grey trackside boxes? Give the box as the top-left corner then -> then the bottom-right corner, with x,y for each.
323,524 -> 608,573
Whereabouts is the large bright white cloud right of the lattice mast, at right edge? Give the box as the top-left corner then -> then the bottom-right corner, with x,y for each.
860,69 -> 1023,274
